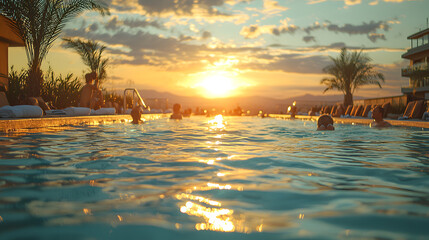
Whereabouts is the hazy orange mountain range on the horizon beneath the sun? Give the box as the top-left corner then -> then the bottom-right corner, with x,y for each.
132,90 -> 362,113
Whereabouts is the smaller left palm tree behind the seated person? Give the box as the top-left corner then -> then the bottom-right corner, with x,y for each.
63,38 -> 109,85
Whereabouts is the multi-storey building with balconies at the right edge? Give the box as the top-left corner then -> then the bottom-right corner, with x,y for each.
401,28 -> 429,101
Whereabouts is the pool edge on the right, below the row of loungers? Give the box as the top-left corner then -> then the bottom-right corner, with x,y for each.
269,114 -> 429,128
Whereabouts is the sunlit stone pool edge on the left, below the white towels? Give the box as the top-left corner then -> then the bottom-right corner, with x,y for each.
0,114 -> 171,133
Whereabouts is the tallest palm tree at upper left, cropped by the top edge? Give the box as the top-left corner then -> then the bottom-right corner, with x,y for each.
0,0 -> 109,97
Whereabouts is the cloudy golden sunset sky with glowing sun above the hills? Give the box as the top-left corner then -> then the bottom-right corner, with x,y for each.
9,0 -> 427,99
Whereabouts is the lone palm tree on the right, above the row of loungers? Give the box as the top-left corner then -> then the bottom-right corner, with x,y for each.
320,48 -> 384,106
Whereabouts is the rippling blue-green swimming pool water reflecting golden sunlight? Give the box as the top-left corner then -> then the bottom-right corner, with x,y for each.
0,117 -> 429,239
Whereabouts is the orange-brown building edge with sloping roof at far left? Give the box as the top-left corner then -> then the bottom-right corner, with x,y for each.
0,15 -> 25,87
